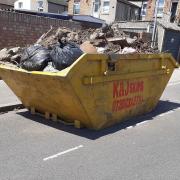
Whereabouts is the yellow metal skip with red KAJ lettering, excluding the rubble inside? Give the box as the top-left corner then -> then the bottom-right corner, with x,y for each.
0,54 -> 178,130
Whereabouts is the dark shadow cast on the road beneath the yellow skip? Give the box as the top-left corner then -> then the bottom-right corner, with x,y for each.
18,101 -> 180,140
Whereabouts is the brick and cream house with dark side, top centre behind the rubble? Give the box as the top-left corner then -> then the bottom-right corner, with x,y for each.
68,0 -> 140,23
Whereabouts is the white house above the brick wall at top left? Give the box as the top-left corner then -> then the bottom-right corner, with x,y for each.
14,0 -> 67,14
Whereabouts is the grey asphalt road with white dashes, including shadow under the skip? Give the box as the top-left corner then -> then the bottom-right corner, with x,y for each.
0,75 -> 180,180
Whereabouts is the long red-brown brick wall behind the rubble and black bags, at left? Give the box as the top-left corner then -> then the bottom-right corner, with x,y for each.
0,10 -> 82,49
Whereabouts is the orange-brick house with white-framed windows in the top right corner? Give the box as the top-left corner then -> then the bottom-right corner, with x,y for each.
145,0 -> 180,22
